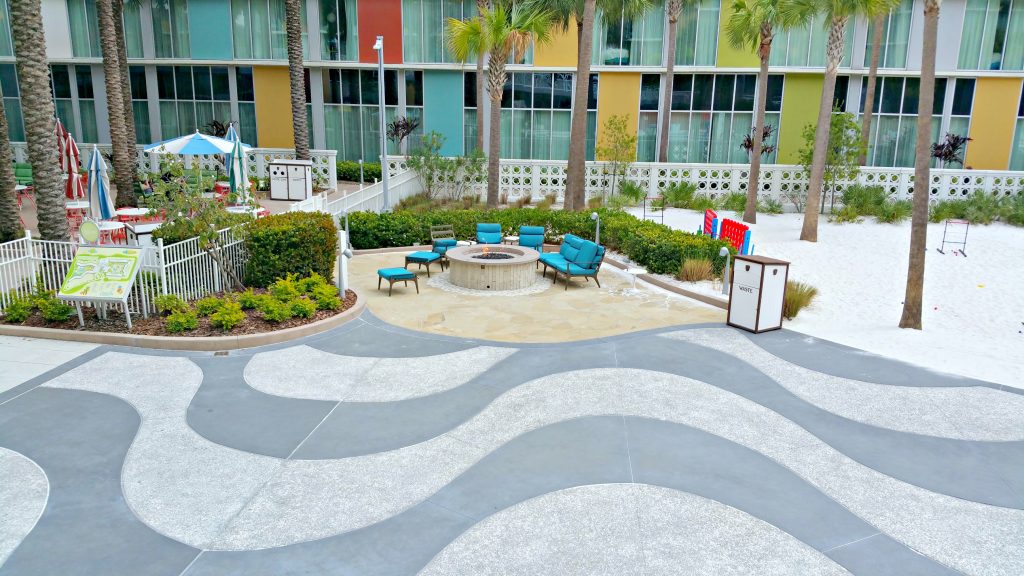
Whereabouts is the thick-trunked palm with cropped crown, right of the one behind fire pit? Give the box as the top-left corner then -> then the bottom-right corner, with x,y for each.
557,0 -> 651,210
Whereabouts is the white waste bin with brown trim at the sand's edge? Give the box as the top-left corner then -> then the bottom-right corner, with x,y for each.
726,256 -> 790,333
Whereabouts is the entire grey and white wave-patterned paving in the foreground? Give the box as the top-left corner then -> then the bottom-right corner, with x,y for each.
0,313 -> 1024,576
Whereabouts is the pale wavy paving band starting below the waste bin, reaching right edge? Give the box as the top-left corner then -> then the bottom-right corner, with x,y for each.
662,328 -> 1024,442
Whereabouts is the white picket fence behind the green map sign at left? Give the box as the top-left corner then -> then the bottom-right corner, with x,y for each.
0,229 -> 246,316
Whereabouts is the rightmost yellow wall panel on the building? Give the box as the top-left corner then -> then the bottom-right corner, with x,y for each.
965,78 -> 1021,170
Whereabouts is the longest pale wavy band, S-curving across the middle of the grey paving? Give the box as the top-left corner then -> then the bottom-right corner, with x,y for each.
37,353 -> 1024,574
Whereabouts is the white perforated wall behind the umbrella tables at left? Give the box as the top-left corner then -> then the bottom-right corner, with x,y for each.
11,142 -> 338,183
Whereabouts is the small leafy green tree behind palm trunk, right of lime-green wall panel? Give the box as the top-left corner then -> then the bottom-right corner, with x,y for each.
800,110 -> 864,213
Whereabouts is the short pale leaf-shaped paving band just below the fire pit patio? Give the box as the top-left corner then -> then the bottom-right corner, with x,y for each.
245,345 -> 516,402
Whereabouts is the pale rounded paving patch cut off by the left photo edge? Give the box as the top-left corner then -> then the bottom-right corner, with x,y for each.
0,448 -> 50,566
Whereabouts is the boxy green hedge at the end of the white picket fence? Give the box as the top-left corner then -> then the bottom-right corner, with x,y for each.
245,212 -> 338,288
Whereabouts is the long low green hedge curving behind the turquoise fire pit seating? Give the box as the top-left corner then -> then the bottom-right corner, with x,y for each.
349,208 -> 735,274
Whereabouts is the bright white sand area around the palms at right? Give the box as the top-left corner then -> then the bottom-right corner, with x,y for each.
622,209 -> 1024,388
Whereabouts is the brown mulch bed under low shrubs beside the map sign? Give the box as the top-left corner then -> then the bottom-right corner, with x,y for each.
9,289 -> 355,338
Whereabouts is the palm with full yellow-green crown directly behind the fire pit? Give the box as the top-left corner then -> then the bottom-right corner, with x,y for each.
447,2 -> 552,208
